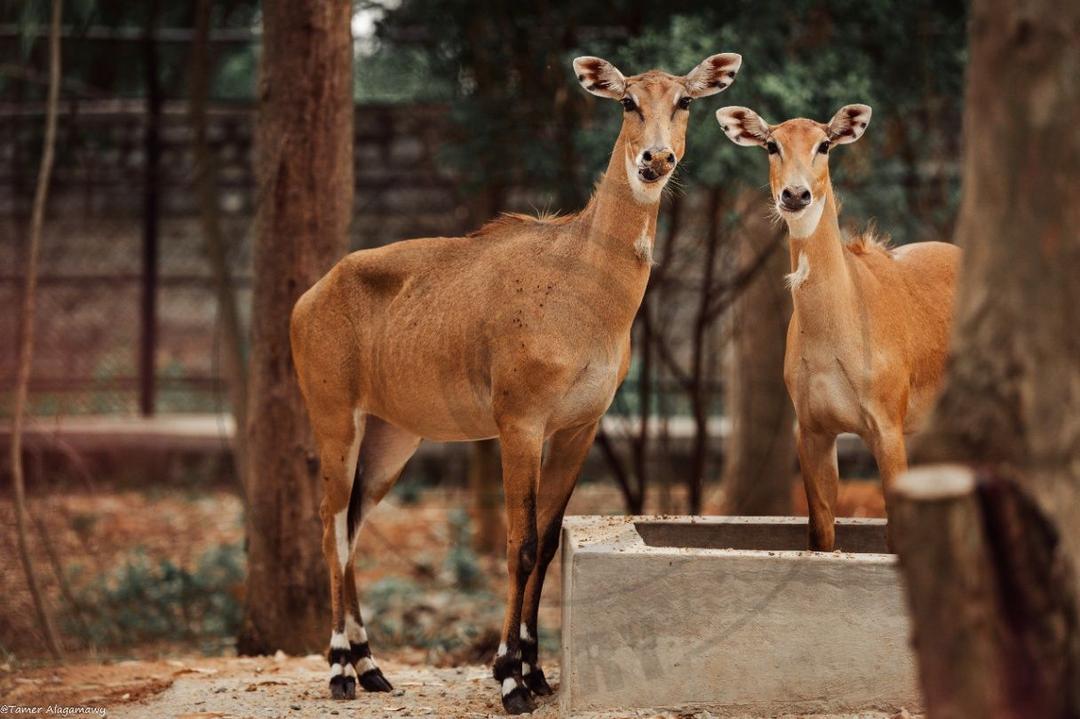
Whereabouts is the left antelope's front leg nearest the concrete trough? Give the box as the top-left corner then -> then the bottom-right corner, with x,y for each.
521,423 -> 599,696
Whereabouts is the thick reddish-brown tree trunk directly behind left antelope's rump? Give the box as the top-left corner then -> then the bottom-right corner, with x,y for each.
239,0 -> 353,653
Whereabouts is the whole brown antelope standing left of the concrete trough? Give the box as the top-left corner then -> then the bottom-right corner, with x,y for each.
292,54 -> 741,714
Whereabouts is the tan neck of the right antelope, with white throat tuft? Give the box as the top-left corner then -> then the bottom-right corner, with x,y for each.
788,185 -> 852,331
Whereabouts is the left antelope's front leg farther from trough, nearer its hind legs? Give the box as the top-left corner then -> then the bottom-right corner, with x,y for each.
492,424 -> 543,714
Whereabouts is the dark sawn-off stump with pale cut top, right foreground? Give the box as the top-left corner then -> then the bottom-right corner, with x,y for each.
889,464 -> 1078,719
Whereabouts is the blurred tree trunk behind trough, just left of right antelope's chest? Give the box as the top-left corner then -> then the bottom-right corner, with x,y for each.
718,207 -> 795,515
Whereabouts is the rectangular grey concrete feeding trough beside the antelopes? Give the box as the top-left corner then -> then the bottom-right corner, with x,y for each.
559,517 -> 920,717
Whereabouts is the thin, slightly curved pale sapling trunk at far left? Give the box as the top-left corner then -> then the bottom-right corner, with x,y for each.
11,0 -> 62,660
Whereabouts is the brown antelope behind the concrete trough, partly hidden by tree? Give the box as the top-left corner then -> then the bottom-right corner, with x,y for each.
716,105 -> 960,552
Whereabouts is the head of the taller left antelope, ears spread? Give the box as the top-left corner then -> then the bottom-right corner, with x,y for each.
573,53 -> 742,203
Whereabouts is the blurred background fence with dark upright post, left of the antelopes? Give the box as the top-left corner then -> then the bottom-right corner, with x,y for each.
0,101 -> 465,415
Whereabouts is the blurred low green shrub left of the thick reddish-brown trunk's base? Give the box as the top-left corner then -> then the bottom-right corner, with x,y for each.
65,537 -> 244,652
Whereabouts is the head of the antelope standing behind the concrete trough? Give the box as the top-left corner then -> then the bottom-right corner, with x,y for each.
716,105 -> 870,238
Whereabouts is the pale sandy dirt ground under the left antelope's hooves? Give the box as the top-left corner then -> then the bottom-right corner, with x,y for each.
0,654 -> 918,719
